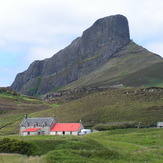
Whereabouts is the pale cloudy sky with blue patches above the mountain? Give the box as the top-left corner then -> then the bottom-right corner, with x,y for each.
0,0 -> 163,86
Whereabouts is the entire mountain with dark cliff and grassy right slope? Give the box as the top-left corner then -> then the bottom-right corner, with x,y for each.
11,15 -> 163,96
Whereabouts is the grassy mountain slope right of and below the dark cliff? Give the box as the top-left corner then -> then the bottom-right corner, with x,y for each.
62,41 -> 163,89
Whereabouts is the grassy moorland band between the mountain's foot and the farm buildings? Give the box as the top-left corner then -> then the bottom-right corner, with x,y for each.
0,88 -> 163,135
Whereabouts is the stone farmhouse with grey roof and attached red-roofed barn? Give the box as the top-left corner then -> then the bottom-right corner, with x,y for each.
20,116 -> 83,136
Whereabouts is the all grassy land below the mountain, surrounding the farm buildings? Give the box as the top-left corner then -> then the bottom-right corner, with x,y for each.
0,88 -> 163,163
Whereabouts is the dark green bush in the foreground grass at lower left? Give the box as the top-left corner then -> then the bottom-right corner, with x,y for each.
0,138 -> 37,156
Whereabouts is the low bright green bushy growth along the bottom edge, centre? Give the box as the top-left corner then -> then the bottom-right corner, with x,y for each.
43,149 -> 123,163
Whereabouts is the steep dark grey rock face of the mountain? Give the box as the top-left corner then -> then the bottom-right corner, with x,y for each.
11,15 -> 130,95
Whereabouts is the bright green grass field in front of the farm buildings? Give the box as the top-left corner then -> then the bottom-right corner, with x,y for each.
0,129 -> 163,163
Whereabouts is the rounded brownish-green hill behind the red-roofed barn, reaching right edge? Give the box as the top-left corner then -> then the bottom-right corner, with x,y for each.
52,88 -> 163,126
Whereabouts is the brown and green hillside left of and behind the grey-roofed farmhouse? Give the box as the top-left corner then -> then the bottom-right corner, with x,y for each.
0,88 -> 51,135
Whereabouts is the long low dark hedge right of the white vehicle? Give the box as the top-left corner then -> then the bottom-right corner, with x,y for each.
94,122 -> 137,131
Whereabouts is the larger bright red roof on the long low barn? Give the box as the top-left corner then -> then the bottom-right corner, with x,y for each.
50,123 -> 81,131
